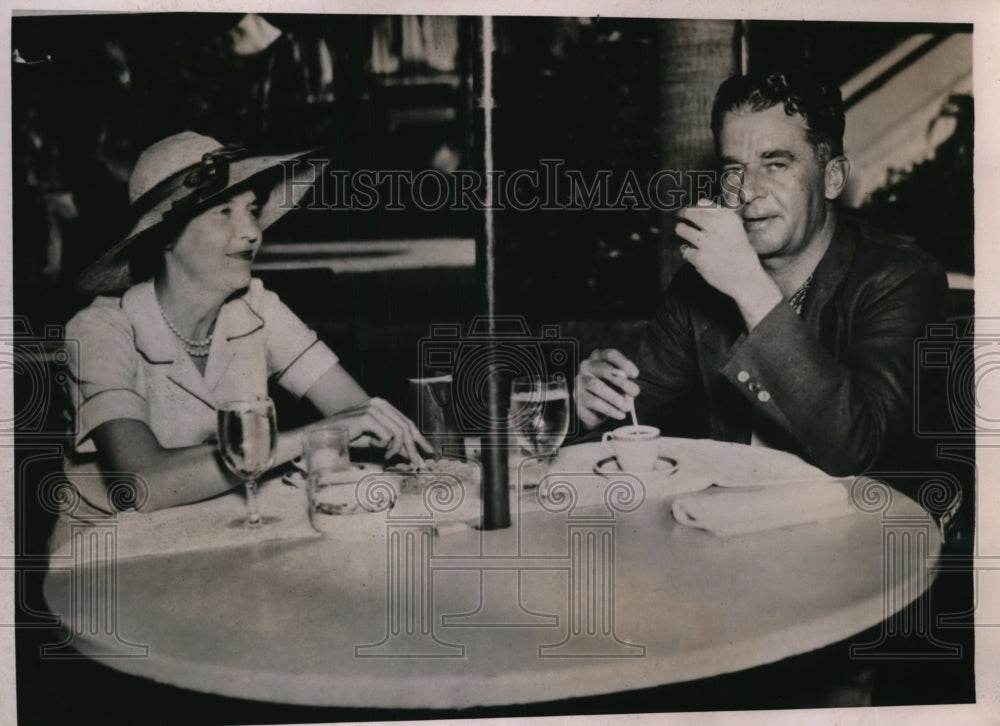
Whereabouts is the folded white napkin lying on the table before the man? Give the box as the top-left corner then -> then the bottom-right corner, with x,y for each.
672,479 -> 856,537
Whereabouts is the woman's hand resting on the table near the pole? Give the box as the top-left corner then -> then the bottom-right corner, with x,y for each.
314,398 -> 436,463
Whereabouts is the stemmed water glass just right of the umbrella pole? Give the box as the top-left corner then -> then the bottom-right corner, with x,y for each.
508,375 -> 569,490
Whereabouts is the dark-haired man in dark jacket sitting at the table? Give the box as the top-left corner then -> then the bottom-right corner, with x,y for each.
575,73 -> 946,476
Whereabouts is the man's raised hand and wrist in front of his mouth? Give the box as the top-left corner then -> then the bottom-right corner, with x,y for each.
674,202 -> 782,330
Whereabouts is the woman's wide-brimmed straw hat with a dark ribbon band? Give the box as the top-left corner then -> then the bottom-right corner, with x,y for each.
76,131 -> 316,293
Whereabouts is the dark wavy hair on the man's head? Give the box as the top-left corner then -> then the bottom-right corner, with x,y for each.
712,72 -> 844,162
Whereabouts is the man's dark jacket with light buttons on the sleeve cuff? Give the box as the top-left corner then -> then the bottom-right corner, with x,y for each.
634,214 -> 947,476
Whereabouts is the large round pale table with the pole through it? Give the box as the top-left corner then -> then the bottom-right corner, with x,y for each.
45,439 -> 940,708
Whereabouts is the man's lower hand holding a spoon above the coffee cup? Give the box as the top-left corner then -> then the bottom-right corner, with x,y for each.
574,348 -> 639,429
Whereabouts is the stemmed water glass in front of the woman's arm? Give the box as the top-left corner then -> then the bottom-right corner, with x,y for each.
217,396 -> 278,529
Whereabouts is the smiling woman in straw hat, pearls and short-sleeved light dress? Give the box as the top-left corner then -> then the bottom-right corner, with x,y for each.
66,132 -> 433,511
